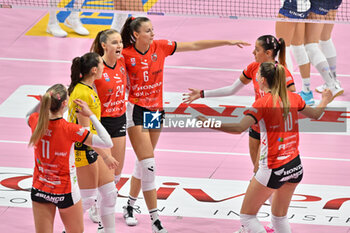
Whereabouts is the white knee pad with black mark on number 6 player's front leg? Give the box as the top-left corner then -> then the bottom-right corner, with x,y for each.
140,158 -> 156,191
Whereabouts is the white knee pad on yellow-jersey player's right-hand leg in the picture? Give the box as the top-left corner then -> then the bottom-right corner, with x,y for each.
98,181 -> 117,216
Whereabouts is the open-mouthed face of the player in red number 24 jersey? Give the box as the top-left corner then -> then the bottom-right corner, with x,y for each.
101,32 -> 123,59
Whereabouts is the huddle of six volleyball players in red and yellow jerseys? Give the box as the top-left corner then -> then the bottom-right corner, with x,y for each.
27,1 -> 340,233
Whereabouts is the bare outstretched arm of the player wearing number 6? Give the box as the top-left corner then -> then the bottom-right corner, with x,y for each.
176,40 -> 250,52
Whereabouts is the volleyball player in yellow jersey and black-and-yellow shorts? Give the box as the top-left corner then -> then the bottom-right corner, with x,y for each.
68,53 -> 118,233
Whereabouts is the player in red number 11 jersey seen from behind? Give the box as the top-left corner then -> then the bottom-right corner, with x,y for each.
27,84 -> 112,233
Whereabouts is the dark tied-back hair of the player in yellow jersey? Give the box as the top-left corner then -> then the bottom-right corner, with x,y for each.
68,53 -> 100,95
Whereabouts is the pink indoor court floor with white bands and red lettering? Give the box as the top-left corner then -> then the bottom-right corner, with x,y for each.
0,2 -> 350,233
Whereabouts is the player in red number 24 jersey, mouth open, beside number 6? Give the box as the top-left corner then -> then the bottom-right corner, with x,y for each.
89,29 -> 127,222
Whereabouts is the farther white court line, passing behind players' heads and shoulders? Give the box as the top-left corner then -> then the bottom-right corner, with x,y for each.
0,57 -> 350,77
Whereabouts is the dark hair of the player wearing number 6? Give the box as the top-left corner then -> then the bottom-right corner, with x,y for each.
121,17 -> 150,48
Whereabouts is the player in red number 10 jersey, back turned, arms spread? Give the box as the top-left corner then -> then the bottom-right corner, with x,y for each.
198,62 -> 333,233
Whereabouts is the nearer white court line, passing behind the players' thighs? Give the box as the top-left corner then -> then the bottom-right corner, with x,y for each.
0,140 -> 350,162
